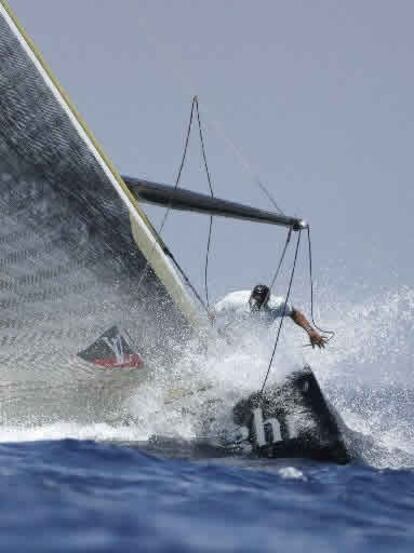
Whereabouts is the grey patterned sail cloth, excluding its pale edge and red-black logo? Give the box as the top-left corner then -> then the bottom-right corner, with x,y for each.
0,2 -> 194,420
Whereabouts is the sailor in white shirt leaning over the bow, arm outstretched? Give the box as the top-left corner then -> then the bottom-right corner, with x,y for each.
211,284 -> 326,348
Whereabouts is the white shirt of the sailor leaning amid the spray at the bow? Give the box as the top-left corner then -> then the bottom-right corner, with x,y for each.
214,290 -> 293,325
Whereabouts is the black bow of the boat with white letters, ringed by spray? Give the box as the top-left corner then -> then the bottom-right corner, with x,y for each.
233,367 -> 351,464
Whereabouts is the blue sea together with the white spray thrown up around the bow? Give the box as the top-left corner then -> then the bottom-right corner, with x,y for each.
0,288 -> 414,551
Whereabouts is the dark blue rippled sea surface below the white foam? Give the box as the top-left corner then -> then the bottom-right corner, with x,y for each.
0,439 -> 414,552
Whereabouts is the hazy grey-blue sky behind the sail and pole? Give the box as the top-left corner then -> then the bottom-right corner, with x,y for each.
10,0 -> 414,306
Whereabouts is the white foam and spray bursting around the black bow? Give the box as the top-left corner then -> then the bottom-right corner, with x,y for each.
0,287 -> 414,474
